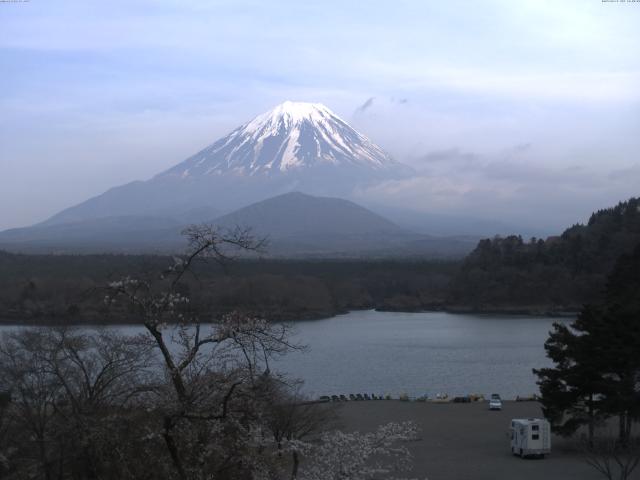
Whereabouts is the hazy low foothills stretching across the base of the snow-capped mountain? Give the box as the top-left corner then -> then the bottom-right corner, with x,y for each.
0,192 -> 475,258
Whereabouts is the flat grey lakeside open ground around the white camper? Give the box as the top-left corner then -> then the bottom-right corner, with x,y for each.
338,400 -> 608,480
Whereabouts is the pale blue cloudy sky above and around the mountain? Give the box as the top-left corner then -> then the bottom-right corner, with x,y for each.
0,0 -> 640,230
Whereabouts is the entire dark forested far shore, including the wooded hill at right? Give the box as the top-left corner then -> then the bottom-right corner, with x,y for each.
0,198 -> 640,323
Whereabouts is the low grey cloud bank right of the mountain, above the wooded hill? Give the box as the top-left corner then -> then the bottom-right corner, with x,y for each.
357,149 -> 640,233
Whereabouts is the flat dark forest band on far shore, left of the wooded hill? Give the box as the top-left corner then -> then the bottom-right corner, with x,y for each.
0,252 -> 459,323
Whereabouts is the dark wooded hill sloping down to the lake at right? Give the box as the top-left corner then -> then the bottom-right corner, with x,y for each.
450,198 -> 640,310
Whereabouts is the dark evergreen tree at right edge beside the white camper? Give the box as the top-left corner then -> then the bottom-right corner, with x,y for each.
534,245 -> 640,444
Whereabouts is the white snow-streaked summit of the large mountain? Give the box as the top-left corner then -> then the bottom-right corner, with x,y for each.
164,101 -> 399,177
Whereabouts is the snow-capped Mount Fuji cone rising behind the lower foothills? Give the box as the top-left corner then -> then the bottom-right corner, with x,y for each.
41,101 -> 412,225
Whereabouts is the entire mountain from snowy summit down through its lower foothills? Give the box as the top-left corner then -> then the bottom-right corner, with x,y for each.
0,102 -> 512,256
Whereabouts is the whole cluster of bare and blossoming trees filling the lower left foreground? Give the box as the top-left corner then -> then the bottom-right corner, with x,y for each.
0,226 -> 428,480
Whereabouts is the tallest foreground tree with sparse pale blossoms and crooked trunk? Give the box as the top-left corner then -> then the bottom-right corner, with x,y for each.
105,225 -> 297,480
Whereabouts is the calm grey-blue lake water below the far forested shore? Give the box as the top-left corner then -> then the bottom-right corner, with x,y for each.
0,311 -> 569,398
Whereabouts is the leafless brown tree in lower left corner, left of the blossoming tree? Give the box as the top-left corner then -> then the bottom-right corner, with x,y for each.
0,328 -> 156,479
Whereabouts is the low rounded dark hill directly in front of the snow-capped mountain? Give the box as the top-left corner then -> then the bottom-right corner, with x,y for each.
213,192 -> 475,257
